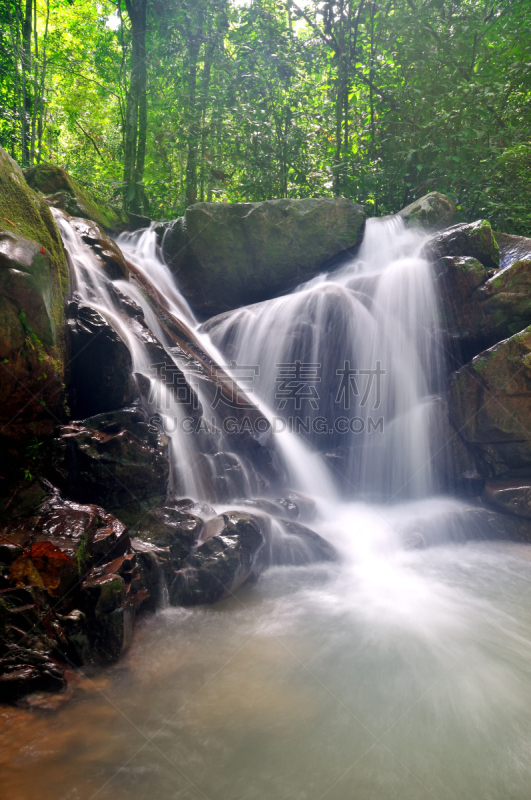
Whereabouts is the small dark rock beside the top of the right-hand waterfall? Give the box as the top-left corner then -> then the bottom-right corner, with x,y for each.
428,220 -> 500,269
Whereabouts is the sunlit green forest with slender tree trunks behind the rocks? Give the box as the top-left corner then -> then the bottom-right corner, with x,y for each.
0,0 -> 531,235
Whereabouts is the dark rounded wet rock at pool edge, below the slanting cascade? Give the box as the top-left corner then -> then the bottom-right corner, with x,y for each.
168,511 -> 265,606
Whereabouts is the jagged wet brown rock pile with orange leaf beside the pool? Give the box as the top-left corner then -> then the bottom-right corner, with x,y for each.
0,484 -> 149,702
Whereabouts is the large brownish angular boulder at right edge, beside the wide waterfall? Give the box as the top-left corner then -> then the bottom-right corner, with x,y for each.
450,327 -> 531,478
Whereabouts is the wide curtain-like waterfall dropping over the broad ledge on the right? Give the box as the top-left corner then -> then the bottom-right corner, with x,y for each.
203,217 -> 443,500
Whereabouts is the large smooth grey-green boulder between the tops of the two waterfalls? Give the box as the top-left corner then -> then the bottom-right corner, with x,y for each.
162,198 -> 365,316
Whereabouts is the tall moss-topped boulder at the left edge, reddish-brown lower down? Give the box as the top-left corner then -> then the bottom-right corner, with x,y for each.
0,148 -> 68,454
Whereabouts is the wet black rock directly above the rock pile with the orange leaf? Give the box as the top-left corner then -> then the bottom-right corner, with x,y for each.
53,408 -> 170,508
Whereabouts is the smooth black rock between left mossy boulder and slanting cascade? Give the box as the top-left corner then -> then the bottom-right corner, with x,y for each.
68,301 -> 135,419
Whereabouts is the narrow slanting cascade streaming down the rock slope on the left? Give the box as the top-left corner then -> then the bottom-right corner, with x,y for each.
54,211 -> 331,503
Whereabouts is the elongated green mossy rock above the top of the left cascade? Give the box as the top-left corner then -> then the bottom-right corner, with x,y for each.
24,164 -> 127,229
